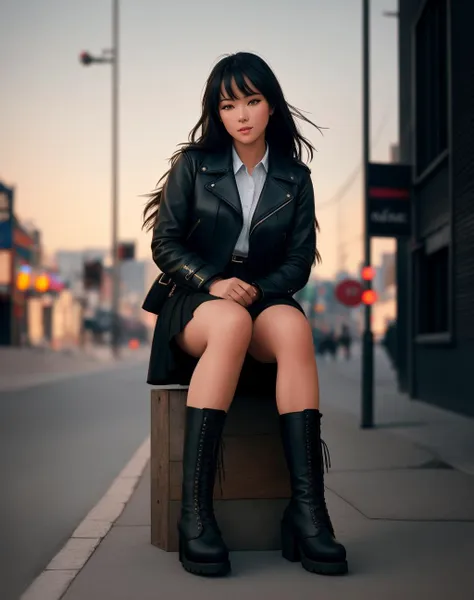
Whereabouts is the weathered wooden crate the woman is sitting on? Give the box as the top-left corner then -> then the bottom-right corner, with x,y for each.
151,386 -> 290,552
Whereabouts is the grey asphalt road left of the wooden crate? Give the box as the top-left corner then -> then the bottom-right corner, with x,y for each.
0,364 -> 149,600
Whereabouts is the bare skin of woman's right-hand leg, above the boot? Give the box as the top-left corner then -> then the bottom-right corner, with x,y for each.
249,305 -> 319,414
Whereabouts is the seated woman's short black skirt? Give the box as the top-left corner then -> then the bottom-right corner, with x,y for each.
147,262 -> 304,395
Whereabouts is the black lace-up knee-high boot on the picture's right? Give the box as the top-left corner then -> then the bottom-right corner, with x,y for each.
280,409 -> 347,575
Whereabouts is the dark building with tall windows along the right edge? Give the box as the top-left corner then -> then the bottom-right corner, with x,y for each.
397,0 -> 474,415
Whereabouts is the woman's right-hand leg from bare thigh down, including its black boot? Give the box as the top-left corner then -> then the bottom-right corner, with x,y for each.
249,306 -> 347,575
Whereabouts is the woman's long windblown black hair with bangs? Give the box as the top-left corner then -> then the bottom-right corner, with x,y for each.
143,52 -> 321,248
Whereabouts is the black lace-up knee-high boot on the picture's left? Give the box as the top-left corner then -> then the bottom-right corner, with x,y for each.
178,406 -> 230,575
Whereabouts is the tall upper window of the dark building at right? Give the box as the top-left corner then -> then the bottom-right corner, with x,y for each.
415,0 -> 448,175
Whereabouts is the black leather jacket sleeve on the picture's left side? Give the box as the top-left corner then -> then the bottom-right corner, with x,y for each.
151,152 -> 219,291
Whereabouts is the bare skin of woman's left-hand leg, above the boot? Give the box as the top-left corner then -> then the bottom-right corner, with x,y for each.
176,300 -> 252,411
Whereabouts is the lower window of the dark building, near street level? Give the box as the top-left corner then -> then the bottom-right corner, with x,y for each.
416,246 -> 449,335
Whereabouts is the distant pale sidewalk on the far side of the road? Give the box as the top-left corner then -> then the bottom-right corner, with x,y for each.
0,346 -> 150,392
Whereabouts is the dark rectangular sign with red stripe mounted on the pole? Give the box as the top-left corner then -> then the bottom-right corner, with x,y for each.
368,163 -> 411,237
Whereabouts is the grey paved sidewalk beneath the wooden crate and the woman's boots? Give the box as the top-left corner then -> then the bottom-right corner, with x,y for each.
24,356 -> 474,600
